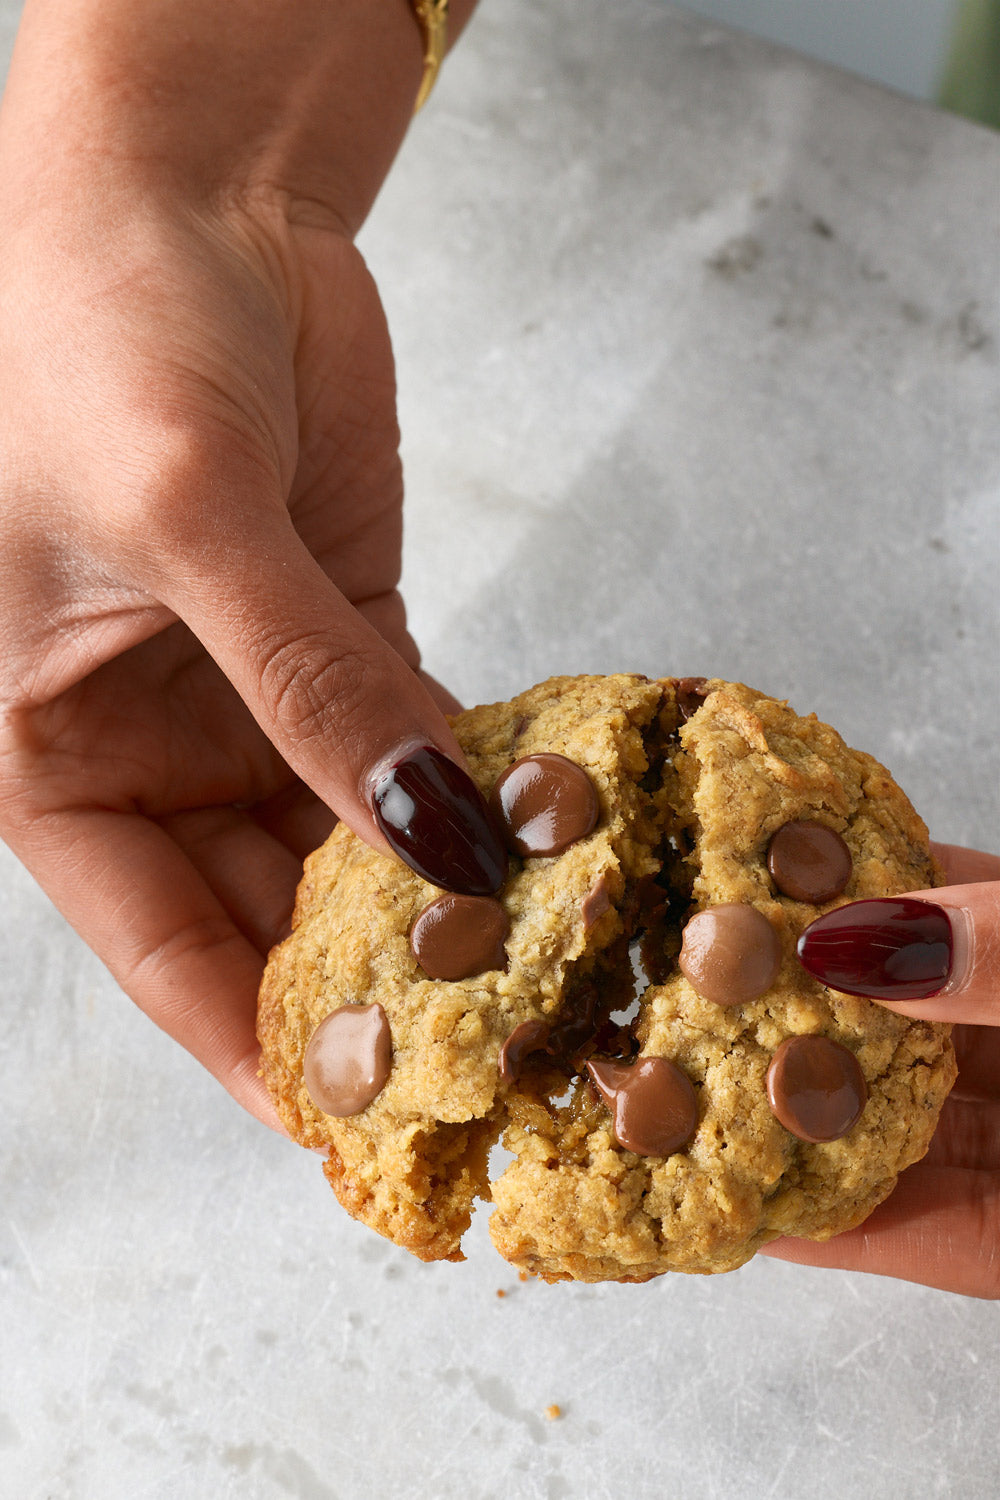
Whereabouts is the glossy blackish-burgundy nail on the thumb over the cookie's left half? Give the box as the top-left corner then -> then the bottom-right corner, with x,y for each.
372,746 -> 507,896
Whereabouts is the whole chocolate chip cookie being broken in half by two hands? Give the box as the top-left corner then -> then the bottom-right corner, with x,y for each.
258,675 -> 955,1281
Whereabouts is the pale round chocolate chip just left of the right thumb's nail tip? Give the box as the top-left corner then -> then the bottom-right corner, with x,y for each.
678,902 -> 781,1005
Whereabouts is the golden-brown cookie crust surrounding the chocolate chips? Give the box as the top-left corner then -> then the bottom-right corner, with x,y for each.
259,677 -> 954,1281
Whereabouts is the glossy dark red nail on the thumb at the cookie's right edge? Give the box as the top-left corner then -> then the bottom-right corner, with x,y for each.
798,896 -> 955,1001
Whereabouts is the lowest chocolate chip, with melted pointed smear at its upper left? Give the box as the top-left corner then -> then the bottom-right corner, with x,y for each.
586,1058 -> 699,1157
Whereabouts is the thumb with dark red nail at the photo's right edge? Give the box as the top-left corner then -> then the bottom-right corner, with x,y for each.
799,848 -> 1000,1026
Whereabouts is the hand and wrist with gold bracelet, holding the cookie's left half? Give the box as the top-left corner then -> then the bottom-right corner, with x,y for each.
0,0 -> 485,1128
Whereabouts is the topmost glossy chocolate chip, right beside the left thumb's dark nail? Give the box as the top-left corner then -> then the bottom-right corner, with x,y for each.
490,752 -> 600,858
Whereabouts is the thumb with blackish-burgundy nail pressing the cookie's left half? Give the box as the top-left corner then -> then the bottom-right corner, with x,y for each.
168,513 -> 507,896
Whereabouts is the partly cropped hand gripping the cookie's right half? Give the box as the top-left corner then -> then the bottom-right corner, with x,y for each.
762,845 -> 1000,1298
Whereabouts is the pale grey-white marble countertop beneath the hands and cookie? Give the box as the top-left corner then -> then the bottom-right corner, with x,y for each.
0,0 -> 1000,1500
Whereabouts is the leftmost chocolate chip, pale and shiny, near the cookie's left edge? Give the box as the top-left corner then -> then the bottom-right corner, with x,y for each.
303,1002 -> 393,1119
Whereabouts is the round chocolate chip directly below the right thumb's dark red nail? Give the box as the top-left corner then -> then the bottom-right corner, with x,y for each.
768,1037 -> 868,1142
